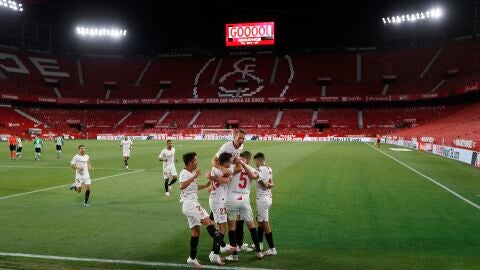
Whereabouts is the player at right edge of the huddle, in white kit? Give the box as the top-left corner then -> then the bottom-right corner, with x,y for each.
253,153 -> 277,256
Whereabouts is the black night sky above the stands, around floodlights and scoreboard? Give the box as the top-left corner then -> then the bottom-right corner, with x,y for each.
0,0 -> 474,53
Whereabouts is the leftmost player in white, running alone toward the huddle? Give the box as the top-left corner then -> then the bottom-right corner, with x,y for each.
70,144 -> 92,207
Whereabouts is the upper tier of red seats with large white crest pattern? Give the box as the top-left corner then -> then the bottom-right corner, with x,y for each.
0,40 -> 480,98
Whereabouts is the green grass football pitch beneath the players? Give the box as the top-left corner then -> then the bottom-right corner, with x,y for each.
0,141 -> 480,269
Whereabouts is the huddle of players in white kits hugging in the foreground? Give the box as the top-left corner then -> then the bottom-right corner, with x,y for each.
179,130 -> 277,267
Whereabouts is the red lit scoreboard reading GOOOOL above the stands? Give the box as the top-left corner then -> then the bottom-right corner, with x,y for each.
225,22 -> 275,47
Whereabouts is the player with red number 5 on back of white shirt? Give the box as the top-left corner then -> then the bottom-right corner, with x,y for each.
225,151 -> 263,261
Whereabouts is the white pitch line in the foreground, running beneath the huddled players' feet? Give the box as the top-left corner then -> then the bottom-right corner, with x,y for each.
0,252 -> 273,270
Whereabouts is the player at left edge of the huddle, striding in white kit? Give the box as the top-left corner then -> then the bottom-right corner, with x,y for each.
180,152 -> 232,268
